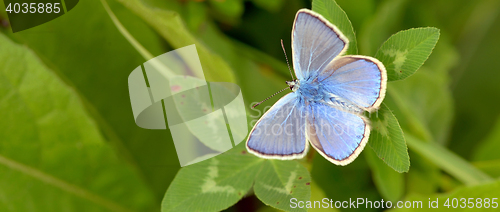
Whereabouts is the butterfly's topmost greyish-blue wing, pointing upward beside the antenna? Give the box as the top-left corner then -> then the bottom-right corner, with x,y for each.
292,9 -> 349,80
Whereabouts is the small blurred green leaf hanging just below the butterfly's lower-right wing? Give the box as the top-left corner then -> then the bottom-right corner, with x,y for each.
365,149 -> 405,202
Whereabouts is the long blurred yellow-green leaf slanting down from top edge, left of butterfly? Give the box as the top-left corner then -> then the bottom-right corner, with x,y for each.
117,0 -> 235,82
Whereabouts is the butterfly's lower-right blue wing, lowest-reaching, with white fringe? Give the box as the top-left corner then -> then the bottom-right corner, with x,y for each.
307,103 -> 370,166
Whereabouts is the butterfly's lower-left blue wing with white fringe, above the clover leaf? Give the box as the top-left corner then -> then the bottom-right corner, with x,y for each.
246,93 -> 307,160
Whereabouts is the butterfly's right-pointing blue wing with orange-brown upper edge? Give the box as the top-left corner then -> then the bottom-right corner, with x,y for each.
317,55 -> 387,112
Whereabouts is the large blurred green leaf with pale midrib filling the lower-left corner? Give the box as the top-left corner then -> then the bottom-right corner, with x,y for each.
0,34 -> 155,211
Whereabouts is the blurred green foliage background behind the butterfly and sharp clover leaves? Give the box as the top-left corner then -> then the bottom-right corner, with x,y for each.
0,0 -> 500,211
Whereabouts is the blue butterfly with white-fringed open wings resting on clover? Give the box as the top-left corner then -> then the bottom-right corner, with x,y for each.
246,9 -> 387,165
